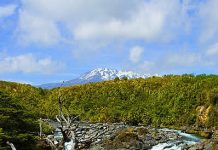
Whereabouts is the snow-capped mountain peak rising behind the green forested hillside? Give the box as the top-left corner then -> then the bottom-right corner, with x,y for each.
38,68 -> 157,89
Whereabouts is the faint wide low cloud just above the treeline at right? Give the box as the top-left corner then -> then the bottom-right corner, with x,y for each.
129,51 -> 209,74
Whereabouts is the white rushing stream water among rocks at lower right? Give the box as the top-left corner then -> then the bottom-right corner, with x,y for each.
151,128 -> 200,150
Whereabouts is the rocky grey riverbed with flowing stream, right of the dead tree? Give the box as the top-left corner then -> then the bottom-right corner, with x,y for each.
46,122 -> 216,150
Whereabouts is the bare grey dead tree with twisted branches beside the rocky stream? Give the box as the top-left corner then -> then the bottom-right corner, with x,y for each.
45,82 -> 107,150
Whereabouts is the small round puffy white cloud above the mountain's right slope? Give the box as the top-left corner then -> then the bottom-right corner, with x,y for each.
129,46 -> 144,63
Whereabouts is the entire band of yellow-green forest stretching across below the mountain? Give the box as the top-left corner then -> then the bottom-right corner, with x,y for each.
0,75 -> 218,149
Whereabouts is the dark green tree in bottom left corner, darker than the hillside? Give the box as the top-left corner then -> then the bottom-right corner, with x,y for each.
0,91 -> 37,150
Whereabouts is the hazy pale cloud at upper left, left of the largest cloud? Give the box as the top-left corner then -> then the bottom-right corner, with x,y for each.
17,11 -> 61,45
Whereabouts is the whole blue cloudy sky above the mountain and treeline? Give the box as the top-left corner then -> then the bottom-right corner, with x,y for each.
0,0 -> 218,85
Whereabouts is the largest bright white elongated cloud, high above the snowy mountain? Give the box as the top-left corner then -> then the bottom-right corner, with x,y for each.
72,0 -> 184,41
